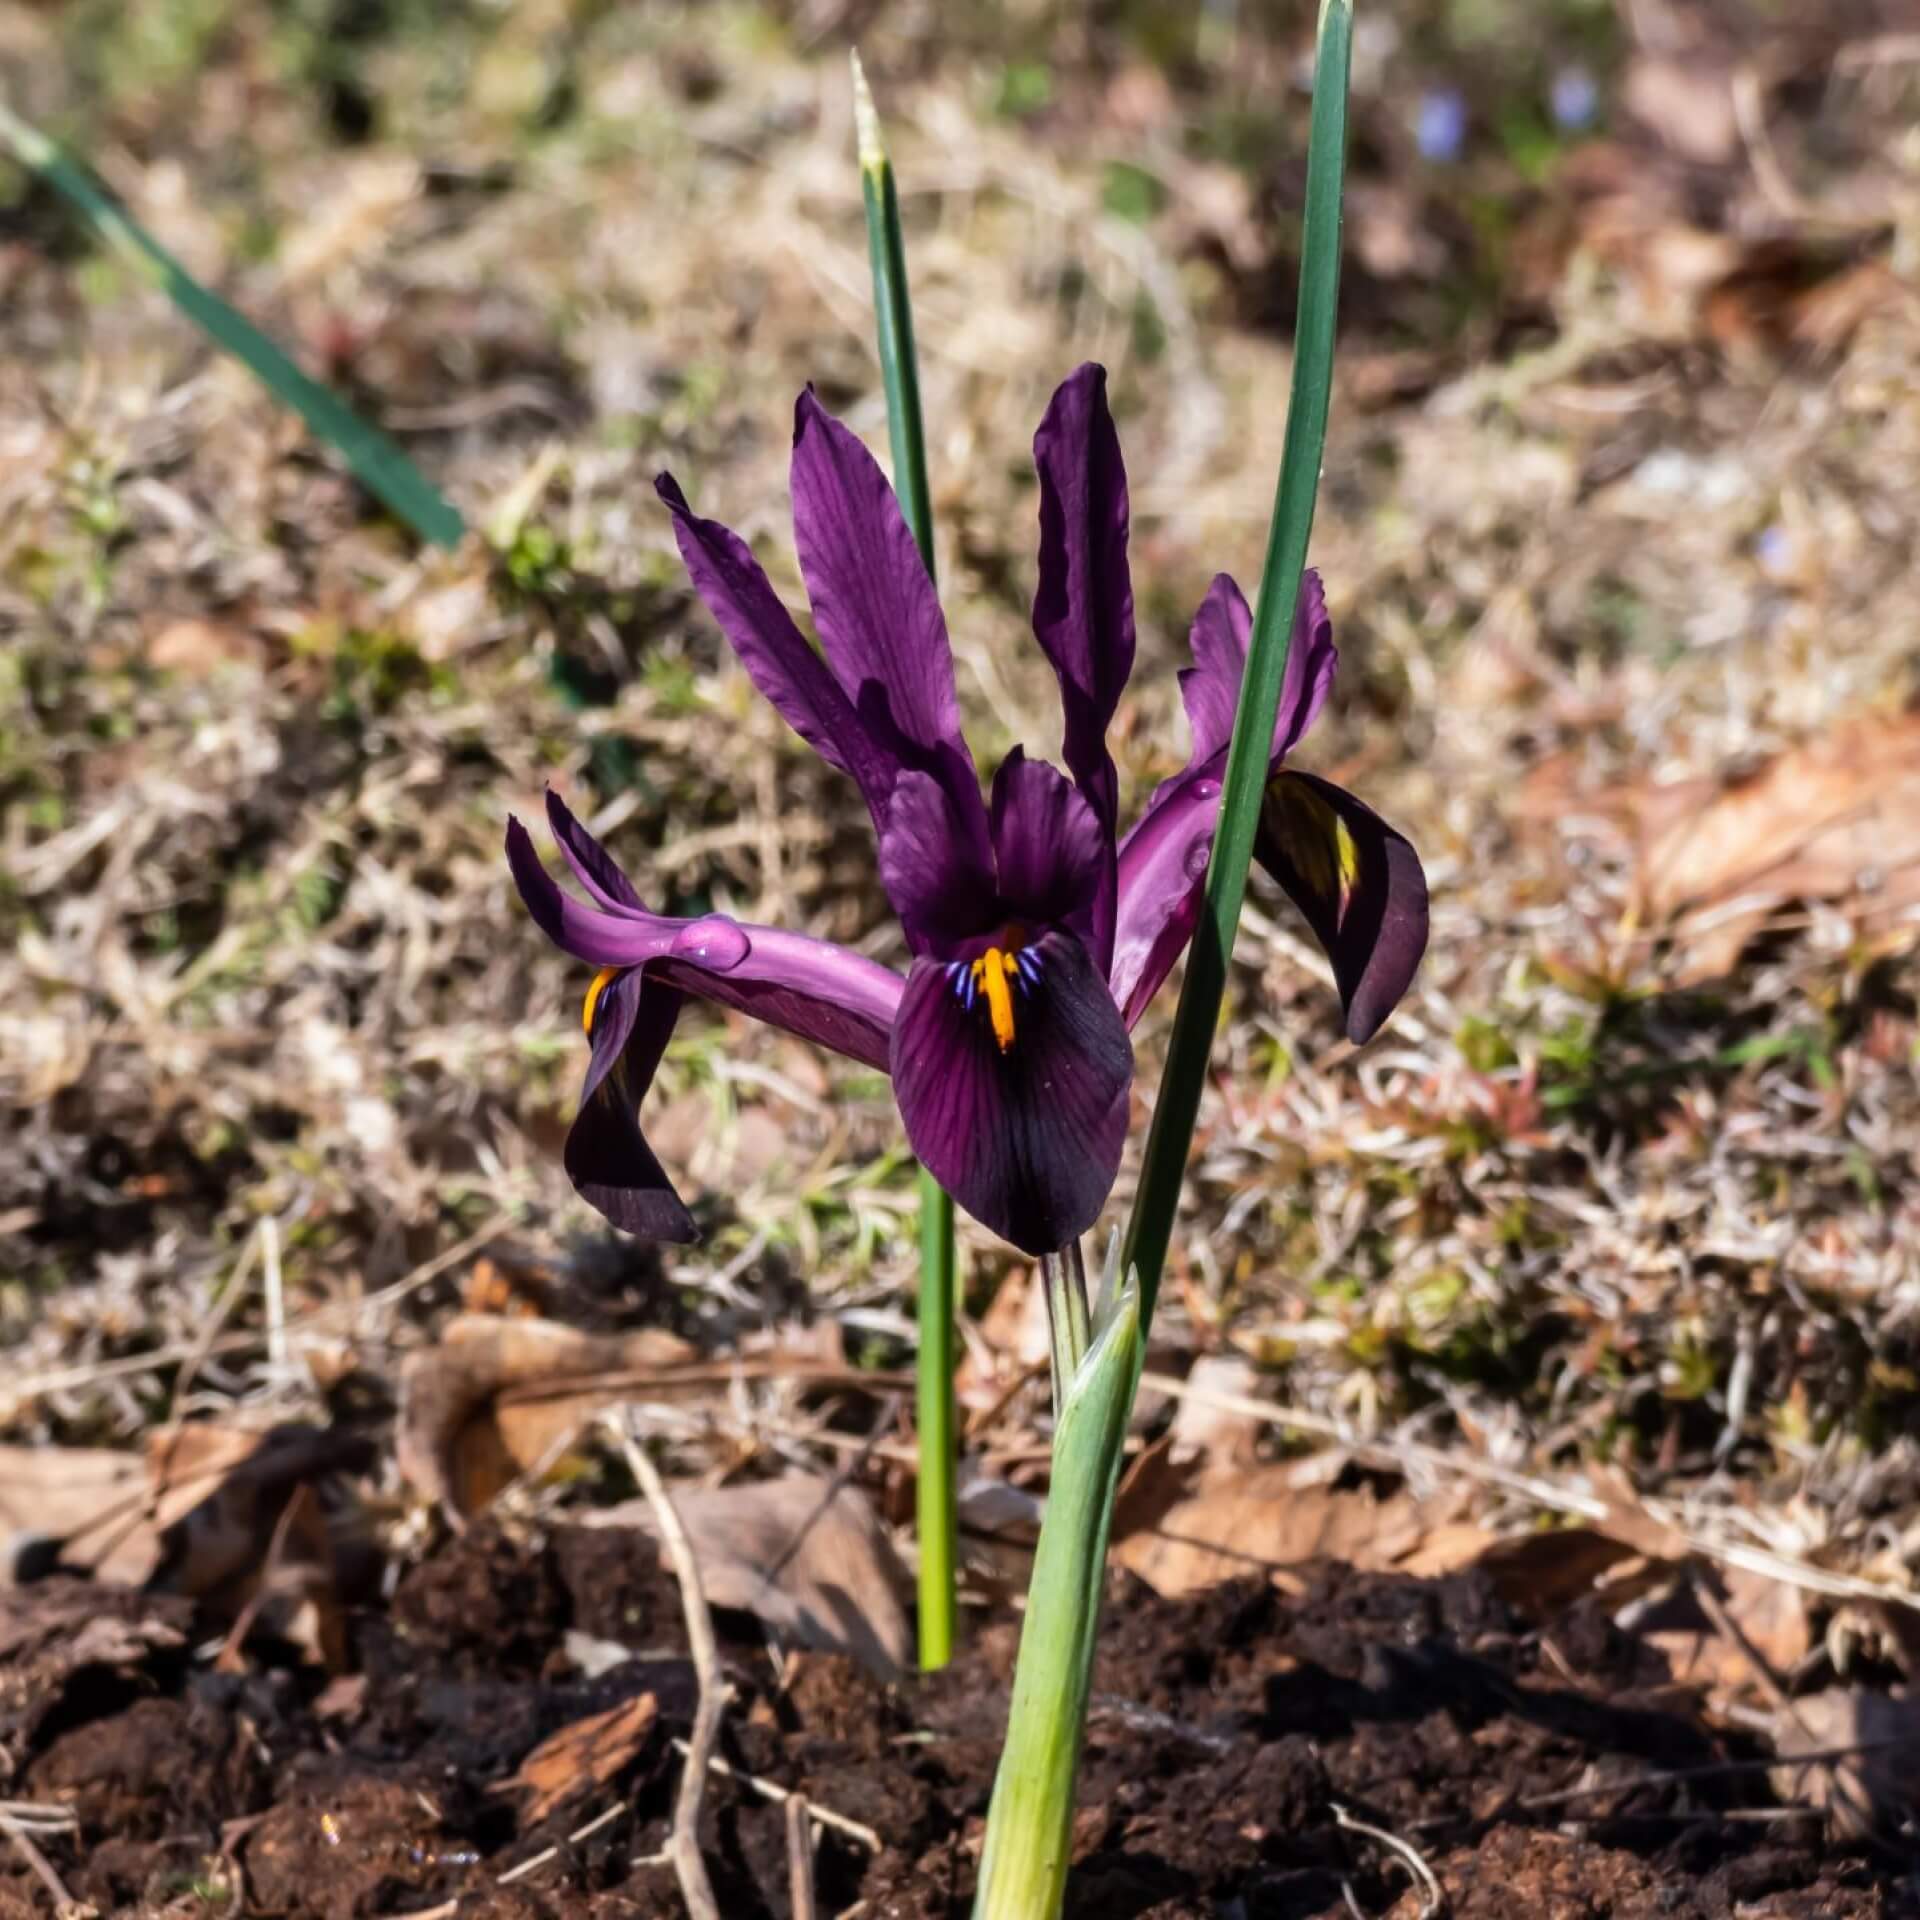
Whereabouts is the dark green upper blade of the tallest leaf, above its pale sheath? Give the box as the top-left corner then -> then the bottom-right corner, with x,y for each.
1121,0 -> 1354,1323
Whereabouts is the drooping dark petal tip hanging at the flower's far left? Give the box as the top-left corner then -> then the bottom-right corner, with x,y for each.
563,968 -> 697,1244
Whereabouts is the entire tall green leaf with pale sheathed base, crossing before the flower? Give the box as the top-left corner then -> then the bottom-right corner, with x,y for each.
973,0 -> 1354,1920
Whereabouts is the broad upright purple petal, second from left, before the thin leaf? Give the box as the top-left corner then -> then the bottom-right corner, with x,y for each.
793,392 -> 987,864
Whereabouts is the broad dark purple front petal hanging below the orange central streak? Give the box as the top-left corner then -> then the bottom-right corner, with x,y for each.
893,931 -> 1133,1254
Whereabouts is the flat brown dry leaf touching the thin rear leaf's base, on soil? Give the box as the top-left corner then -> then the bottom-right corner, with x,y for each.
588,1473 -> 914,1680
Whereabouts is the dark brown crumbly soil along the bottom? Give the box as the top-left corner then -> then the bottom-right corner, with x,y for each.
0,1526 -> 1920,1920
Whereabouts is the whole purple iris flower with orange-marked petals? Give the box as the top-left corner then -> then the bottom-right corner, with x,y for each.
507,367 -> 1427,1254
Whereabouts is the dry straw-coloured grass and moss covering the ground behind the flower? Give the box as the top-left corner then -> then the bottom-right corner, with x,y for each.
0,0 -> 1920,1580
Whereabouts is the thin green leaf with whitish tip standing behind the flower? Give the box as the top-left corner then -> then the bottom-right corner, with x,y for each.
852,54 -> 958,1672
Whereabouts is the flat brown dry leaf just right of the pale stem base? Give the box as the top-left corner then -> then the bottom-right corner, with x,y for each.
1114,1440 -> 1494,1599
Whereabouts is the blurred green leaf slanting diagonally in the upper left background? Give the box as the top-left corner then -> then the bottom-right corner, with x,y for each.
0,106 -> 465,547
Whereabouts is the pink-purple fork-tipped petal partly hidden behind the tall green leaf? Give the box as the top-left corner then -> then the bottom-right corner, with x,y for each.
1108,568 -> 1338,1027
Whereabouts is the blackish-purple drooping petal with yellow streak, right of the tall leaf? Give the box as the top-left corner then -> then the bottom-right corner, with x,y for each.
1254,772 -> 1427,1044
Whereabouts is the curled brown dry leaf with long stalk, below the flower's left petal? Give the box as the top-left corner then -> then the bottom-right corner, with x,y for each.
396,1313 -> 904,1523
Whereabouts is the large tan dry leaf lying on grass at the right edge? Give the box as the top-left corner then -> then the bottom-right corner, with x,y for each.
1620,712 -> 1920,983
